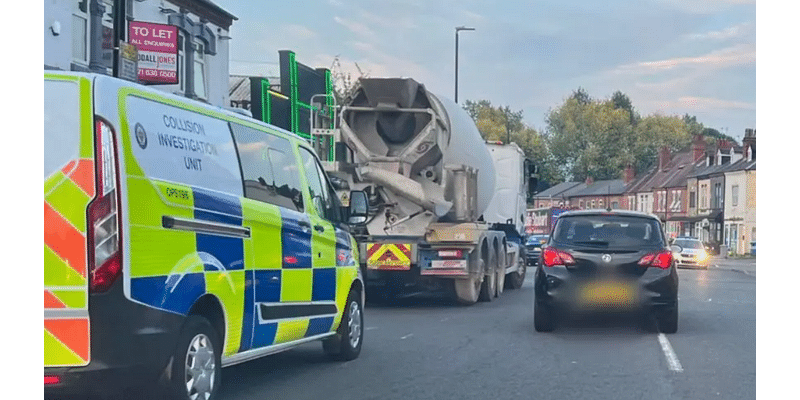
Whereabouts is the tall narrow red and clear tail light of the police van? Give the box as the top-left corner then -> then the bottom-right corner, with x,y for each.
87,118 -> 122,293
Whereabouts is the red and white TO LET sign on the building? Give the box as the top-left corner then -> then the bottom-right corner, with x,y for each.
128,21 -> 178,84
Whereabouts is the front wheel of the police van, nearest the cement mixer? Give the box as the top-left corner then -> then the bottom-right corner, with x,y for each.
322,289 -> 364,361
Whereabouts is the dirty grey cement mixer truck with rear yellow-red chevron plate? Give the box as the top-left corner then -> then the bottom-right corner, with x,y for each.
312,78 -> 536,305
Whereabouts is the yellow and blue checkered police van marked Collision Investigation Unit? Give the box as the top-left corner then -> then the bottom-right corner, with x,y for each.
44,71 -> 367,399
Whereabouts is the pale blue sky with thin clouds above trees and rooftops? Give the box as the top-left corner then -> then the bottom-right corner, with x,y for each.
214,0 -> 756,141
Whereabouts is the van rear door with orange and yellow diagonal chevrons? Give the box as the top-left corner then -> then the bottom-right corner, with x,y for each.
44,72 -> 95,367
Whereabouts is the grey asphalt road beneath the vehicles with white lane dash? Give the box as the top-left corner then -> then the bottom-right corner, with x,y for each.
220,268 -> 756,400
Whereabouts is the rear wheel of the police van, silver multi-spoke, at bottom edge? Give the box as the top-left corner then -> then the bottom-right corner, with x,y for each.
171,315 -> 222,400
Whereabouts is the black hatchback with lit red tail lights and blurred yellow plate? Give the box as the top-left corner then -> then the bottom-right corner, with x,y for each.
534,210 -> 678,333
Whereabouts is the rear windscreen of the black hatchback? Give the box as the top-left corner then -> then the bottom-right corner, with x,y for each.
553,215 -> 665,248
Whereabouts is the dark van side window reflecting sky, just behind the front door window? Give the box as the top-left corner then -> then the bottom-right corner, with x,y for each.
231,123 -> 303,211
